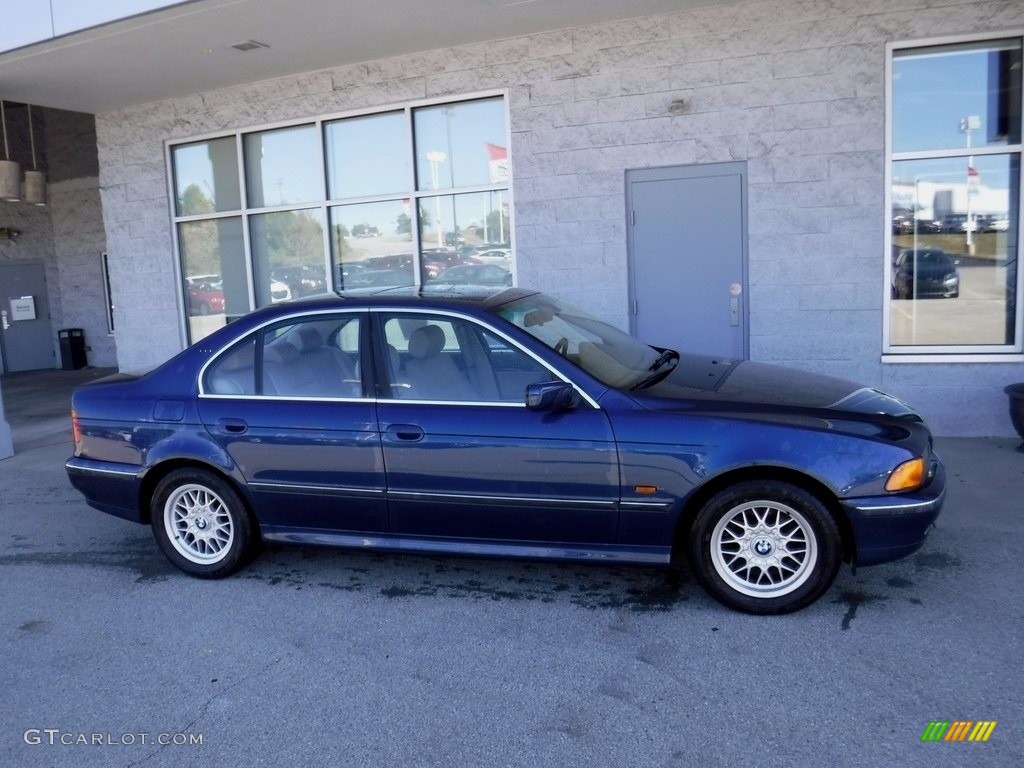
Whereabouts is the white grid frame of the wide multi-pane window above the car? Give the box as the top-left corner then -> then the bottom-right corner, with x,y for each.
164,88 -> 518,348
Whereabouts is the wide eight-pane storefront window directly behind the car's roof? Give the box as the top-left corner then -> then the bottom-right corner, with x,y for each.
171,96 -> 513,341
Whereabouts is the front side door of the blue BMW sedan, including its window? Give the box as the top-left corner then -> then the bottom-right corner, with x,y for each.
373,310 -> 618,546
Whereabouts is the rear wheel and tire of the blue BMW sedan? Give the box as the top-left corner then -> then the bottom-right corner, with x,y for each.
150,468 -> 256,579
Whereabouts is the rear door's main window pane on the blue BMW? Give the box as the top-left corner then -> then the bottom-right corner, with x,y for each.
260,314 -> 362,397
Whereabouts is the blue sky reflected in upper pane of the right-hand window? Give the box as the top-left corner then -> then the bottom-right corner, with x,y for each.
893,41 -> 1020,152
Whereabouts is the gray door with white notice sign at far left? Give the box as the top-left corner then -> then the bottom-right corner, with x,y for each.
0,264 -> 55,373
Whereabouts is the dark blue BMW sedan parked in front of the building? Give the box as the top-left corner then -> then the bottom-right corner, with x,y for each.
67,289 -> 944,613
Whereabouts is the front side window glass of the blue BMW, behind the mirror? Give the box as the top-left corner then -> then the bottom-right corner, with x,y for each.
383,314 -> 553,402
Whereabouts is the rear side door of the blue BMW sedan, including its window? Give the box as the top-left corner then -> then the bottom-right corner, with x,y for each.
200,312 -> 387,534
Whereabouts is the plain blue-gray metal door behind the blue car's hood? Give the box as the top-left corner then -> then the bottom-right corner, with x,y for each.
626,163 -> 748,358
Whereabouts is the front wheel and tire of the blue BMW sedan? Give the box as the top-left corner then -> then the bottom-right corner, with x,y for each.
689,480 -> 842,614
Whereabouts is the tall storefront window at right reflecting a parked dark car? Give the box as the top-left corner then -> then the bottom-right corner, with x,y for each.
886,38 -> 1021,354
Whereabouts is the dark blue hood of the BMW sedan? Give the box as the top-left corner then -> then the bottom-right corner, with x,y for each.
634,354 -> 921,421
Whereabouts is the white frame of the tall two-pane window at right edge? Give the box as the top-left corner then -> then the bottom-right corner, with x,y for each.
882,29 -> 1024,364
